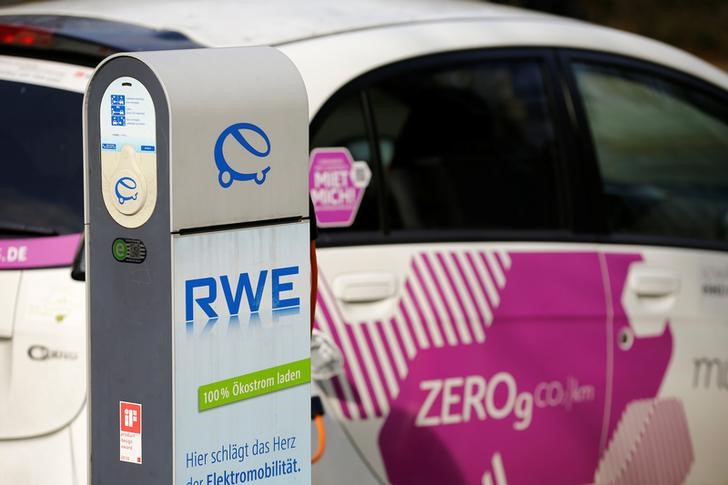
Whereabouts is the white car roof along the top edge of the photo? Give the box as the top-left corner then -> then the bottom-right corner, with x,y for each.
0,0 -> 556,47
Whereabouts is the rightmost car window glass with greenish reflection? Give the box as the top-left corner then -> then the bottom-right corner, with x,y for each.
573,63 -> 728,241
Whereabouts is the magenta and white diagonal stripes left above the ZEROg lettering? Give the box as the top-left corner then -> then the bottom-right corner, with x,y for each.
314,251 -> 511,420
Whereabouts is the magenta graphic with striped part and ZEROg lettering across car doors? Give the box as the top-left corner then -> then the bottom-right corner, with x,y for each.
316,251 -> 672,484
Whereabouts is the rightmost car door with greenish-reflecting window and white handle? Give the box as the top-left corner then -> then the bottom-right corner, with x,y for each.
562,52 -> 728,483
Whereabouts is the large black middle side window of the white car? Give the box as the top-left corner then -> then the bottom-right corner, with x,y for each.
368,60 -> 560,230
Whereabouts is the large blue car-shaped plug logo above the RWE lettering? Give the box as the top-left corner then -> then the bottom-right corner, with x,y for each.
215,123 -> 270,189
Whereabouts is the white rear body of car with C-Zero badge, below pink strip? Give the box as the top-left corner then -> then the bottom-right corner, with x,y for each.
0,268 -> 87,485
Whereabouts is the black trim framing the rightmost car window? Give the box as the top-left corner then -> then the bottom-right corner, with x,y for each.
557,49 -> 728,251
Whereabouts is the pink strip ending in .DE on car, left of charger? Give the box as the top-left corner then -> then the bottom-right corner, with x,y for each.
0,234 -> 81,269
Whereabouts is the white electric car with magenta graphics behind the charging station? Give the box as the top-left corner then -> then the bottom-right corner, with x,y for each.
0,0 -> 728,485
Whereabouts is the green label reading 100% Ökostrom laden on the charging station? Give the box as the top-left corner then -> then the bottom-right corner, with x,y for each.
197,359 -> 311,411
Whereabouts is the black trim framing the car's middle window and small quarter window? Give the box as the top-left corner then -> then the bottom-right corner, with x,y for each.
309,47 -> 579,247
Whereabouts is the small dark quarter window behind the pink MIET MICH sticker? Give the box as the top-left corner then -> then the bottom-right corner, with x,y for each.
310,91 -> 380,236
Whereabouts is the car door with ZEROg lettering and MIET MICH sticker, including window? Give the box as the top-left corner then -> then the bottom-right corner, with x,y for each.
310,49 -> 608,484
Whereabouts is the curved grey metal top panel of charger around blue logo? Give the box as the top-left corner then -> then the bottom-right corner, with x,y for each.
133,47 -> 308,232
